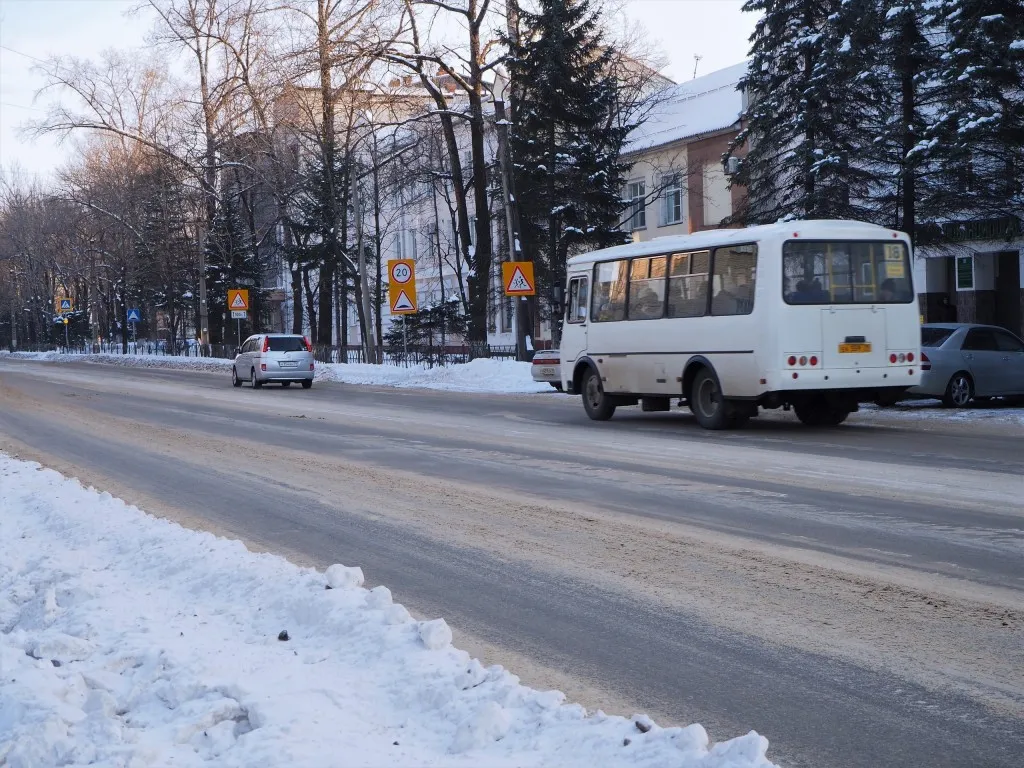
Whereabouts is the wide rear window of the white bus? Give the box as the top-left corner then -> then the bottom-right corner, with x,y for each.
782,241 -> 913,304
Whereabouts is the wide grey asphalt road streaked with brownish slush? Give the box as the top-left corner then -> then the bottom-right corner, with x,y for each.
0,359 -> 1024,768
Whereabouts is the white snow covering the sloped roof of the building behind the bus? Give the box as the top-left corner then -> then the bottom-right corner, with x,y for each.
626,61 -> 748,153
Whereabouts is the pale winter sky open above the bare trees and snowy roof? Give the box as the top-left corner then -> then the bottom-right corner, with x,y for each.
0,0 -> 757,180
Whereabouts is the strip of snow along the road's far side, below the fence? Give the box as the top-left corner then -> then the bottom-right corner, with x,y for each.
0,352 -> 554,394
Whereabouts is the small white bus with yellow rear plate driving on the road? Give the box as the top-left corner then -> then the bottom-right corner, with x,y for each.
560,220 -> 921,429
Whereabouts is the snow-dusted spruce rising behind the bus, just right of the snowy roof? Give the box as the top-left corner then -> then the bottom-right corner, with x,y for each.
726,0 -> 877,224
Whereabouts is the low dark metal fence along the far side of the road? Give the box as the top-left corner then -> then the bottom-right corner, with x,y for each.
16,341 -> 516,368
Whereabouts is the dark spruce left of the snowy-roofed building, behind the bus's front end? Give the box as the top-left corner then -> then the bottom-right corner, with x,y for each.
507,0 -> 634,313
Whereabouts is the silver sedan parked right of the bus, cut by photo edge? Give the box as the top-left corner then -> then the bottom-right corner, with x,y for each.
907,323 -> 1024,408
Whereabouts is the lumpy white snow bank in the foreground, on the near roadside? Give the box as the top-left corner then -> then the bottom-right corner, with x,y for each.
0,455 -> 771,768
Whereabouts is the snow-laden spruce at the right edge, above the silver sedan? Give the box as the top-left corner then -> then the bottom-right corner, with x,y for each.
930,0 -> 1024,227
